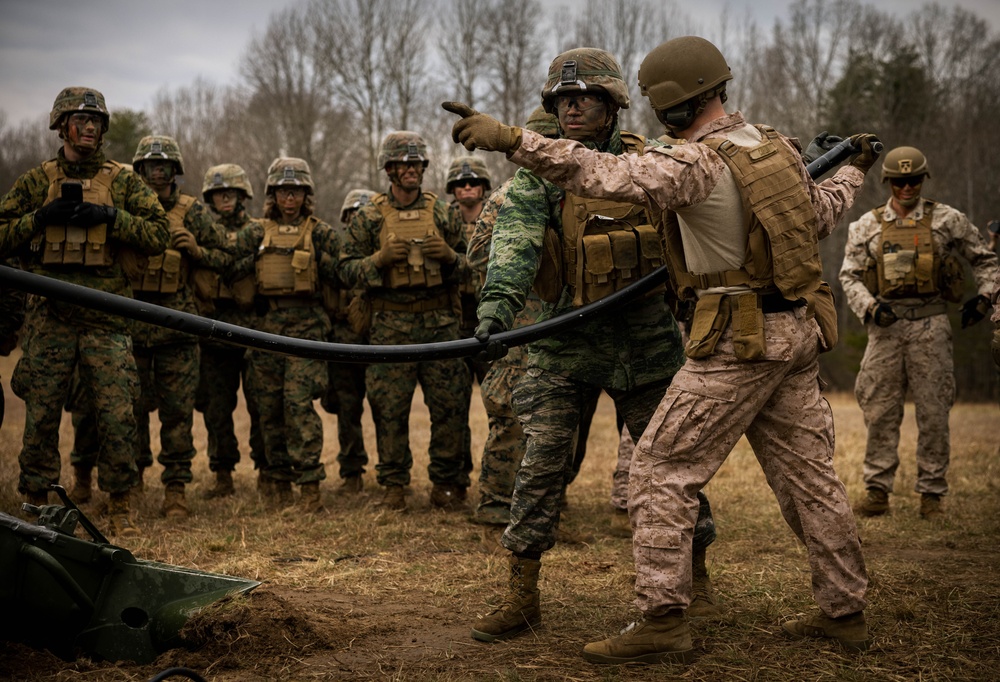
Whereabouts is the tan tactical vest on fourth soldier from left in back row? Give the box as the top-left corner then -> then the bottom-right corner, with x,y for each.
257,216 -> 319,296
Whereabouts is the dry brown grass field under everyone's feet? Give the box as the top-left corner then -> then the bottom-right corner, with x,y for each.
0,346 -> 1000,682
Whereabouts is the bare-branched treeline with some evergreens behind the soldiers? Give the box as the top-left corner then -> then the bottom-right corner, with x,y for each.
0,0 -> 1000,400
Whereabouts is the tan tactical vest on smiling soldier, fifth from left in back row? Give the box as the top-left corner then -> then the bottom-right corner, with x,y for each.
371,192 -> 444,289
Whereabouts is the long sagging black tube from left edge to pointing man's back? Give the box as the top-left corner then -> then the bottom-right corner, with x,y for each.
0,265 -> 667,363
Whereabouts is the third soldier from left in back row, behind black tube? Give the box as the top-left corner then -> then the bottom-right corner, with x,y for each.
194,163 -> 267,498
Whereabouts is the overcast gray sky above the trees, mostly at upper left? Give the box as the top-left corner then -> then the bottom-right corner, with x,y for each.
0,0 -> 1000,123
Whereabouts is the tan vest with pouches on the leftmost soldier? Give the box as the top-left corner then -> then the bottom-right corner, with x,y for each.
34,160 -> 124,268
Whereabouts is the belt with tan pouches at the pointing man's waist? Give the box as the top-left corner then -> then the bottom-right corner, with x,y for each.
684,291 -> 806,361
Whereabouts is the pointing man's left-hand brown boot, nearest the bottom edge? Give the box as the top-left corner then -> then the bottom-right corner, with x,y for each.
583,609 -> 694,663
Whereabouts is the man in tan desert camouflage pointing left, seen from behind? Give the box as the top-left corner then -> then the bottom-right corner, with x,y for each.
446,36 -> 876,663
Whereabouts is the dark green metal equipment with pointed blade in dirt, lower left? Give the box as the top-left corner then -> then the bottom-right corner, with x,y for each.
0,486 -> 260,663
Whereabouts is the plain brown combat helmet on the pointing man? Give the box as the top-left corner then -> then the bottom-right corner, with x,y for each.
639,36 -> 733,128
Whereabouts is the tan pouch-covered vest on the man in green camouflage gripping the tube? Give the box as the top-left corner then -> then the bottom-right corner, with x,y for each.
534,132 -> 665,307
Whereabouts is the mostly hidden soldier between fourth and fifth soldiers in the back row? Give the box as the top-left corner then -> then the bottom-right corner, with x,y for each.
321,189 -> 376,493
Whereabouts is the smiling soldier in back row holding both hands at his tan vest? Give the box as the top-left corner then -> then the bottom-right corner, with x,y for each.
341,131 -> 470,510
